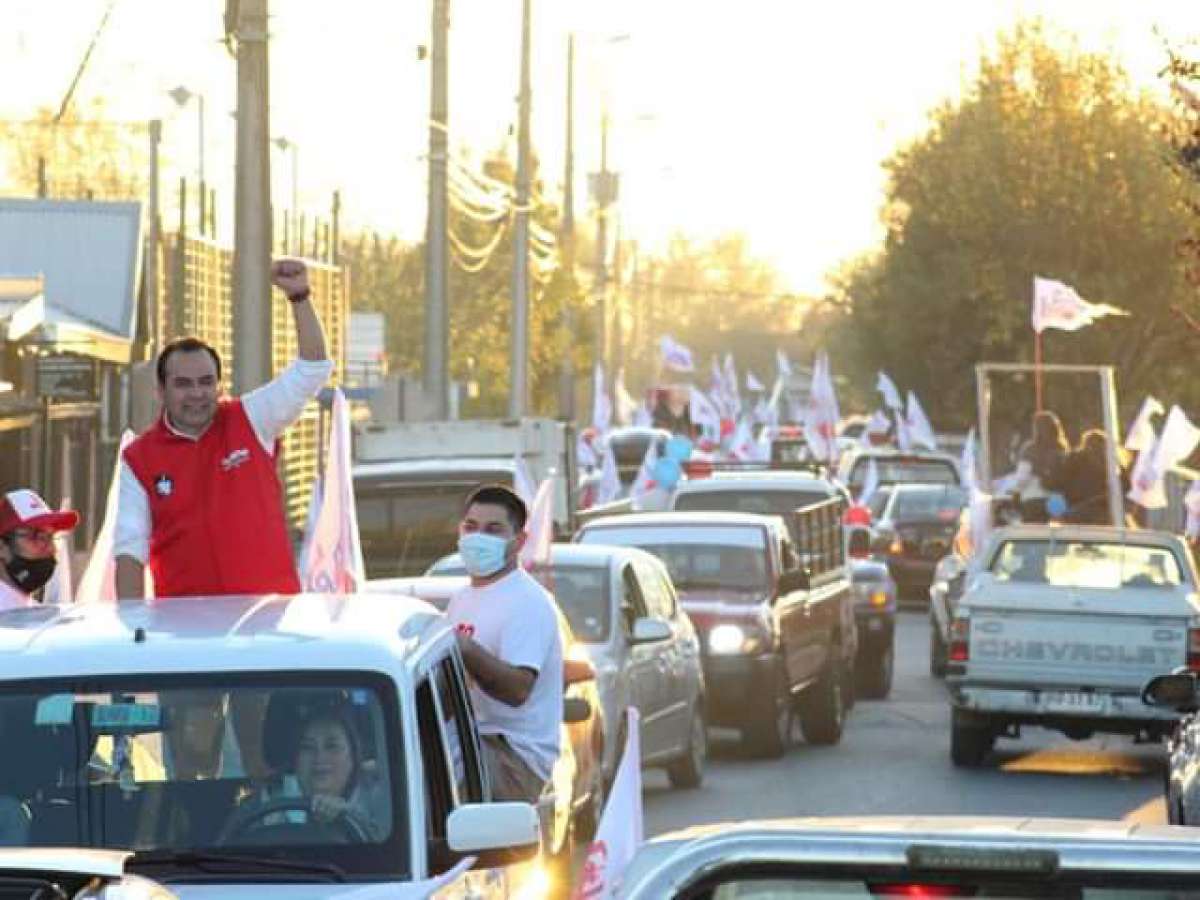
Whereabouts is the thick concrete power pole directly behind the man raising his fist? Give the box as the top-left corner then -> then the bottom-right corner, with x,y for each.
233,0 -> 271,394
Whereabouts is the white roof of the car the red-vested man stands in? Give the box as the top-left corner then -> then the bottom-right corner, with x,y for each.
0,594 -> 449,679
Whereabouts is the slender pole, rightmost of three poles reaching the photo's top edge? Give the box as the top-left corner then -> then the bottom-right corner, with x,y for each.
509,0 -> 530,419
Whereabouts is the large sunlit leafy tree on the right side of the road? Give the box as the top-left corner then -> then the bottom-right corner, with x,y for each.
839,23 -> 1200,424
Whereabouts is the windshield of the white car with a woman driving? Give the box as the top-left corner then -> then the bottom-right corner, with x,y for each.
0,673 -> 408,875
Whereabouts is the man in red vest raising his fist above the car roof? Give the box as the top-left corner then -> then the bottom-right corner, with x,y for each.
114,259 -> 334,598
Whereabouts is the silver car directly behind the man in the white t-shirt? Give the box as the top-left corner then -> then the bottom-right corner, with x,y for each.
428,544 -> 708,787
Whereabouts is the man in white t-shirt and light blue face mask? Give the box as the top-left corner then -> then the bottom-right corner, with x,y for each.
446,485 -> 563,803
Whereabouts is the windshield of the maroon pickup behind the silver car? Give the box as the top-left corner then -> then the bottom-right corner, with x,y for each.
580,526 -> 767,599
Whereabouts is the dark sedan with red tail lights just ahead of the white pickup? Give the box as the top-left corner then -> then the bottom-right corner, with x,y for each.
872,485 -> 967,600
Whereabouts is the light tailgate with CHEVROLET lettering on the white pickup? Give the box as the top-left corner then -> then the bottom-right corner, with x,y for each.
964,592 -> 1192,692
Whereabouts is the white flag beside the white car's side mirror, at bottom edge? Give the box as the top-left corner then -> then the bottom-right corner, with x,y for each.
572,707 -> 644,900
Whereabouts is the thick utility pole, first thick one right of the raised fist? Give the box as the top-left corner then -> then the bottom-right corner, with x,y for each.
424,0 -> 450,419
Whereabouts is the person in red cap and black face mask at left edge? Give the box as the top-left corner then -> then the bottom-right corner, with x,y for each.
0,490 -> 79,610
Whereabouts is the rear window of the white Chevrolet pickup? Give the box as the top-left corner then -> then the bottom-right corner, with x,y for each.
990,540 -> 1183,590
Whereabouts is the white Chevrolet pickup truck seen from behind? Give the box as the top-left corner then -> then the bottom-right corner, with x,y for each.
947,524 -> 1200,766
